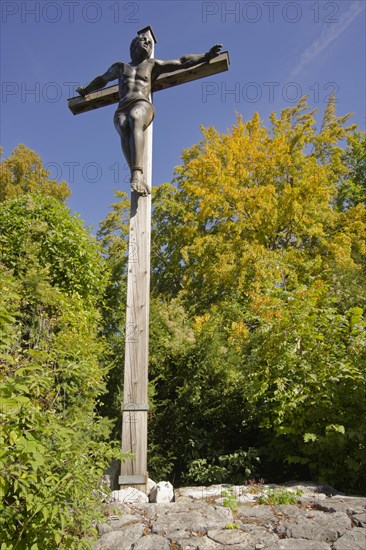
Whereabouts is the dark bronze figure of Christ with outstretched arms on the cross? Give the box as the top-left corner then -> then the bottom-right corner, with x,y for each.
76,33 -> 222,196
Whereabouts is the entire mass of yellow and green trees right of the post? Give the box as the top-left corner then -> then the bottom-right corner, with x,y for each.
147,98 -> 366,491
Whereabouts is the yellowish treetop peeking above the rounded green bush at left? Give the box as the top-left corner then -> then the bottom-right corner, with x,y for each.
0,145 -> 71,202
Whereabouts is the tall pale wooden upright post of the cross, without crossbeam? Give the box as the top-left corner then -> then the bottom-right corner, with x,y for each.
119,28 -> 156,492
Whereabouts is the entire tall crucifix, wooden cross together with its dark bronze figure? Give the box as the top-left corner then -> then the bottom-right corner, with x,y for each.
68,27 -> 229,492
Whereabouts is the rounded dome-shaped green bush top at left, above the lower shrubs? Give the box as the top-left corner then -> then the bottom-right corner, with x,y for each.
0,194 -> 107,305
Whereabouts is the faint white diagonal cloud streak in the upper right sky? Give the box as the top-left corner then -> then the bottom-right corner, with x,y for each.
289,0 -> 366,80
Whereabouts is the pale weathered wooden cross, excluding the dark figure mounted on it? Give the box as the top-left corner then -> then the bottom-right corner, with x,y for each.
68,27 -> 229,492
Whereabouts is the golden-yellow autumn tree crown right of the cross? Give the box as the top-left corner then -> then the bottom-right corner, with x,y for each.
155,98 -> 366,322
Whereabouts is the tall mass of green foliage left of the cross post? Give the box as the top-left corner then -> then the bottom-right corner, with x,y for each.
0,193 -> 119,550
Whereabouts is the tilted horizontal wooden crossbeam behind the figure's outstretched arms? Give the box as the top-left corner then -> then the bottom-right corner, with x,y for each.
67,52 -> 230,115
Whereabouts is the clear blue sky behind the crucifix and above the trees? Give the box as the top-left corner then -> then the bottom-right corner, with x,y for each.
0,0 -> 366,230
